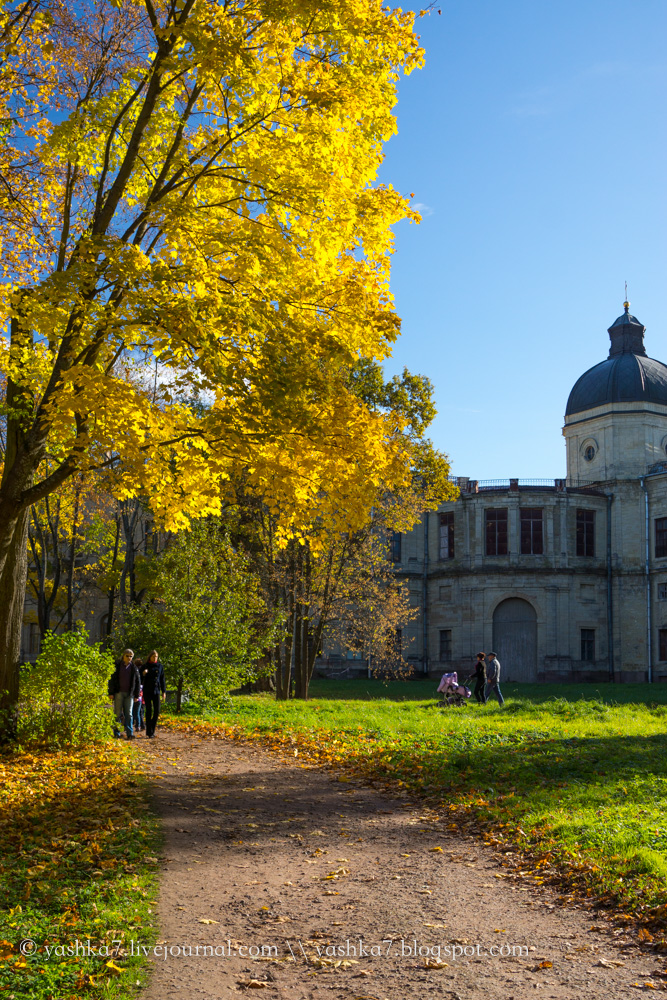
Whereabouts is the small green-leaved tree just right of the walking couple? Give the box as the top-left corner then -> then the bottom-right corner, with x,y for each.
116,519 -> 273,711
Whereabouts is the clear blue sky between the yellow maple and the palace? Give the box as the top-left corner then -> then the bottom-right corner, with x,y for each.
380,0 -> 667,479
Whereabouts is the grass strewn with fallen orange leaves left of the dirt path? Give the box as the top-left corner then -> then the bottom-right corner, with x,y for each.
0,743 -> 157,1000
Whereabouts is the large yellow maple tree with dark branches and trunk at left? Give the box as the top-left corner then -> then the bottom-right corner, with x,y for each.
0,0 -> 438,736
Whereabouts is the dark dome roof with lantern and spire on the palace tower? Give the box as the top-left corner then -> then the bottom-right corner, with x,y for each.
565,303 -> 667,417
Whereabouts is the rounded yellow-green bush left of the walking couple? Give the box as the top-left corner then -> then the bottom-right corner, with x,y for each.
18,629 -> 114,748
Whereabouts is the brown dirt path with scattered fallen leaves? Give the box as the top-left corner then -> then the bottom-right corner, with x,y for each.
135,729 -> 665,1000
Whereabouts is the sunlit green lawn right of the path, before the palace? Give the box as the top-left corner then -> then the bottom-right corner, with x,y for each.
170,680 -> 667,925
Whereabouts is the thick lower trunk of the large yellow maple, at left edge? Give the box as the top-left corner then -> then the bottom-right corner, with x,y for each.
0,509 -> 30,743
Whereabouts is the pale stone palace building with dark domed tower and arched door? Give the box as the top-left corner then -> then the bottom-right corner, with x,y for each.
393,302 -> 667,682
